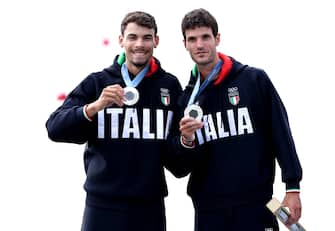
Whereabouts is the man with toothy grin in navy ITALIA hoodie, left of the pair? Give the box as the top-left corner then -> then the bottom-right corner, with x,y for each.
46,11 -> 181,231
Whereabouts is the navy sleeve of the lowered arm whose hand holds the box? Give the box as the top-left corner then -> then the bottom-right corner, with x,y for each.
262,71 -> 302,190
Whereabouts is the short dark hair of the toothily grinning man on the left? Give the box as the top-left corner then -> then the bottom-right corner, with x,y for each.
121,11 -> 157,35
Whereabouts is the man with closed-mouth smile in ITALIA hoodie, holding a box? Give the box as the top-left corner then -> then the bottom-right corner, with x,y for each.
180,9 -> 302,231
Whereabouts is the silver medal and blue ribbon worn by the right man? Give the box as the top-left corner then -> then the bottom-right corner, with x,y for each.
184,60 -> 222,121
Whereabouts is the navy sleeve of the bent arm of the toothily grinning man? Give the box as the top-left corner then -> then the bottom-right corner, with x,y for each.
46,77 -> 96,144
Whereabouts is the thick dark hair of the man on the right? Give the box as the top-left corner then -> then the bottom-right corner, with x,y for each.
181,8 -> 219,39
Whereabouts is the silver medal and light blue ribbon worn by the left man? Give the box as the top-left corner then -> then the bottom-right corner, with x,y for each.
121,63 -> 149,106
